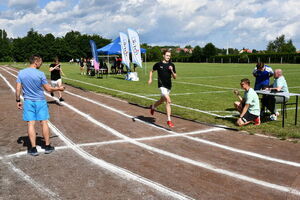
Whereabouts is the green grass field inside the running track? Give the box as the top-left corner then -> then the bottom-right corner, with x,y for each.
4,63 -> 300,139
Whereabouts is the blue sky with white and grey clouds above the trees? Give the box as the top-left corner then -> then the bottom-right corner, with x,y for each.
0,0 -> 300,50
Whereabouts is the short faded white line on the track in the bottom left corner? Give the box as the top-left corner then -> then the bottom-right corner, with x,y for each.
4,161 -> 60,199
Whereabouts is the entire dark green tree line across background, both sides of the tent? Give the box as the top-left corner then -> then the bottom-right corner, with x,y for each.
0,29 -> 300,63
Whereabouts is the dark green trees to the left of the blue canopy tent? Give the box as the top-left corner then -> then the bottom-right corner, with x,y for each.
0,29 -> 111,62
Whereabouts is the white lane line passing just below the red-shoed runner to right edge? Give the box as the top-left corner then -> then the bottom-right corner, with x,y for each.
66,91 -> 300,167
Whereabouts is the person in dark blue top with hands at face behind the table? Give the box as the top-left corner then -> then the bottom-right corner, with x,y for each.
252,62 -> 273,90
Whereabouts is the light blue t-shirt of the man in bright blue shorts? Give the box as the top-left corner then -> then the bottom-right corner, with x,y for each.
17,68 -> 48,101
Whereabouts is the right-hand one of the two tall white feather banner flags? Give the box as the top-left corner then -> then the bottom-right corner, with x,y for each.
128,28 -> 142,67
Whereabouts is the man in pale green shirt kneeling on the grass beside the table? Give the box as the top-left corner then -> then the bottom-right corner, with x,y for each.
234,78 -> 260,126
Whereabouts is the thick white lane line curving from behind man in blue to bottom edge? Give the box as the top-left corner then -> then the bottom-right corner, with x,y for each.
0,69 -> 193,200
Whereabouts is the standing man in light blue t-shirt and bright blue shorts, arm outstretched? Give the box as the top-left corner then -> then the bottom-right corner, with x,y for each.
16,55 -> 64,156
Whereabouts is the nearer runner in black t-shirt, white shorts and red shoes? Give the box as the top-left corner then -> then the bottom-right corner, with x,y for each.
148,51 -> 176,128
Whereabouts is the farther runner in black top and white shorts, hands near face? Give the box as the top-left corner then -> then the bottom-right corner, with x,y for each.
49,58 -> 64,101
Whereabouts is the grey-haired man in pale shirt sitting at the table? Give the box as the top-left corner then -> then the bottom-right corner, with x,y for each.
262,69 -> 289,120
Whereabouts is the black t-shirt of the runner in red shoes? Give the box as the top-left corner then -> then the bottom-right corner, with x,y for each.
153,61 -> 176,90
